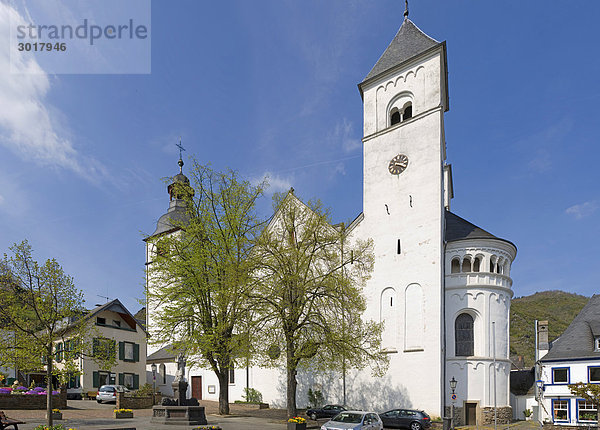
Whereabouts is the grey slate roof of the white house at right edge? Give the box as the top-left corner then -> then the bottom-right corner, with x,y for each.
541,294 -> 600,361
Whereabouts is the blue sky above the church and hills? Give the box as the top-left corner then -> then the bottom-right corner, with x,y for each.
0,0 -> 600,312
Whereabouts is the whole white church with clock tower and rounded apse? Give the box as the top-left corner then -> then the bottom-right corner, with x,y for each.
146,16 -> 517,425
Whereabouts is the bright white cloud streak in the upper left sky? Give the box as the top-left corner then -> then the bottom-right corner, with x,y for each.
0,2 -> 108,182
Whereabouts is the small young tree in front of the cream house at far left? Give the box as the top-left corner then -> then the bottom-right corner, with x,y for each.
0,241 -> 85,426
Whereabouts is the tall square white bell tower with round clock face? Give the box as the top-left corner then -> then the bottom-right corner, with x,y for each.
356,10 -> 450,415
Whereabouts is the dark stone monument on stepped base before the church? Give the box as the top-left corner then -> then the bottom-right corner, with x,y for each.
150,353 -> 206,425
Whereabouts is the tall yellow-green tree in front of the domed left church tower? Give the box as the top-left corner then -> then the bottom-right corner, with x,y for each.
146,161 -> 263,414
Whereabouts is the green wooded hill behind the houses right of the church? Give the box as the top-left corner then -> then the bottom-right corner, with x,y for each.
510,291 -> 589,367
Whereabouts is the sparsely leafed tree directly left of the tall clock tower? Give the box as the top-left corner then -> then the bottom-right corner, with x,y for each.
252,190 -> 387,417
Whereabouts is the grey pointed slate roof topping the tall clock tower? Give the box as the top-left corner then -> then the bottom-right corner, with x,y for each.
363,18 -> 440,82
